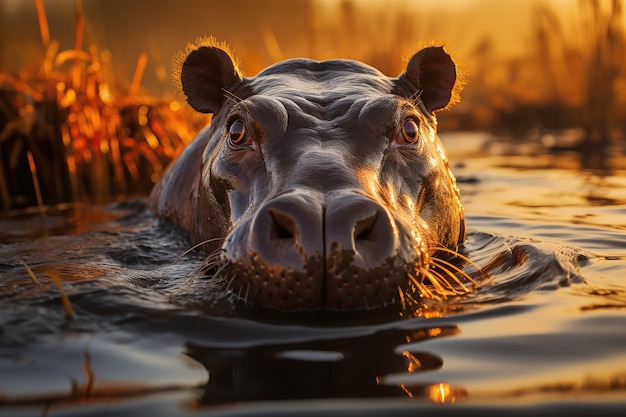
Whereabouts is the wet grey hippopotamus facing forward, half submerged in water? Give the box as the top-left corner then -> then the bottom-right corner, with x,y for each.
149,42 -> 466,311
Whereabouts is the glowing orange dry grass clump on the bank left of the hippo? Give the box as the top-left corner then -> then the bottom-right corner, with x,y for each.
0,0 -> 204,210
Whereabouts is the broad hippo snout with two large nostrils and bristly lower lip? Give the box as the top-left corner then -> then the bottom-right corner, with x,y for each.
224,192 -> 407,310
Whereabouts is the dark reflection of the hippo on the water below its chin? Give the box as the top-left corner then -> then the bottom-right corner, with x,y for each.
185,320 -> 458,407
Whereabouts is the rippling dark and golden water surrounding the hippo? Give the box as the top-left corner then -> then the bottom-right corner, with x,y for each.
0,134 -> 626,416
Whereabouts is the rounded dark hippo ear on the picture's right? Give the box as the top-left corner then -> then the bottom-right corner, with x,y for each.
400,46 -> 457,113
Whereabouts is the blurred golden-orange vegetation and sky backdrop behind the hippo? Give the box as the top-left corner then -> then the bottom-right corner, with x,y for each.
0,0 -> 626,211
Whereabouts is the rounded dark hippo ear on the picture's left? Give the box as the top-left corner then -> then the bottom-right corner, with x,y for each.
180,46 -> 242,113
